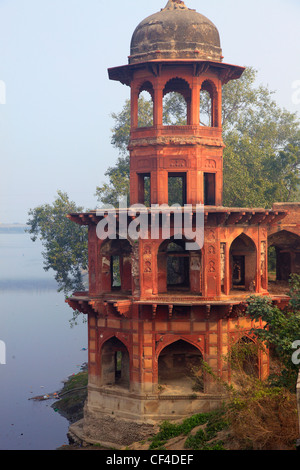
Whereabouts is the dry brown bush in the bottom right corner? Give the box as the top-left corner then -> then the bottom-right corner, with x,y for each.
226,374 -> 299,450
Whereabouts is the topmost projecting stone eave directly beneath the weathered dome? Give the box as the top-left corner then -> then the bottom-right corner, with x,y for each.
108,59 -> 245,86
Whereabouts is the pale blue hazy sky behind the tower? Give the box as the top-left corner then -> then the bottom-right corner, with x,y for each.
0,0 -> 300,223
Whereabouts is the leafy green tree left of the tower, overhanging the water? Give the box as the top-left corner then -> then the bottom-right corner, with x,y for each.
27,191 -> 88,294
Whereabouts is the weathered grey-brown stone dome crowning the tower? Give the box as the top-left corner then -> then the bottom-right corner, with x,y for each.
129,0 -> 222,64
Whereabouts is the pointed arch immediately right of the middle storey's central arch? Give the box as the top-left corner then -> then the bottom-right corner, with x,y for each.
230,233 -> 257,292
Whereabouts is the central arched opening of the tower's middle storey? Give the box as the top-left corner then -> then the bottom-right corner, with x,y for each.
157,237 -> 202,294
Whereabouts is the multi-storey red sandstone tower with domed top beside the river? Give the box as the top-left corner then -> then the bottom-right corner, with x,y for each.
68,0 -> 285,444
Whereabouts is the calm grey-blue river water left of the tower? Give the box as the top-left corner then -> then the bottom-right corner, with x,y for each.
0,229 -> 87,450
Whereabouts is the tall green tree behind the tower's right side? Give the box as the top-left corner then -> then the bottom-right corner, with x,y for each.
222,67 -> 300,207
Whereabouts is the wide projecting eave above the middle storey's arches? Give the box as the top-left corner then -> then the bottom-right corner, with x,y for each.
67,206 -> 288,226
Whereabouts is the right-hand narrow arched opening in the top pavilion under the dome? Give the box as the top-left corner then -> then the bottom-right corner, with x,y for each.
200,80 -> 218,127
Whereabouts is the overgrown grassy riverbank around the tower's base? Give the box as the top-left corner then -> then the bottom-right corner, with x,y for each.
51,364 -> 298,451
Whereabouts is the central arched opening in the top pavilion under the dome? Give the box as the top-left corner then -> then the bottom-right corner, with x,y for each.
163,78 -> 191,126
